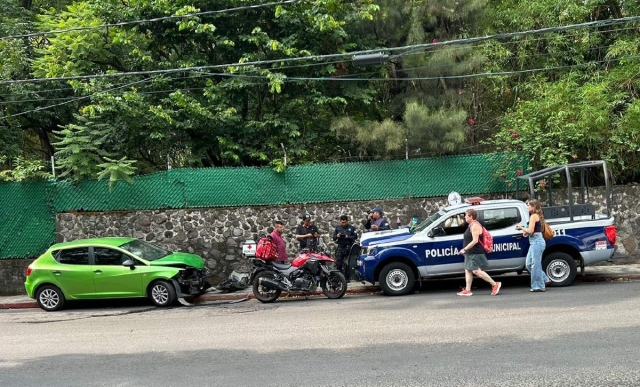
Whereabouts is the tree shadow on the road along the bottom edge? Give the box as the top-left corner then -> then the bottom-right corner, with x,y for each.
0,325 -> 640,387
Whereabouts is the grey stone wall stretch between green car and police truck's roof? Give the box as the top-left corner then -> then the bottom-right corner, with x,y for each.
56,198 -> 446,284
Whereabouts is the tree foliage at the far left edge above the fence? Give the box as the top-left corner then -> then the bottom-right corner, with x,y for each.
0,0 -> 72,174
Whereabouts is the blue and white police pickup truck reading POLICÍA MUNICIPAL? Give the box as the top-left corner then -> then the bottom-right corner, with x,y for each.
355,161 -> 617,296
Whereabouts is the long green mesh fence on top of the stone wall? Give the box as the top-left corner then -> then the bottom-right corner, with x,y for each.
0,154 -> 526,259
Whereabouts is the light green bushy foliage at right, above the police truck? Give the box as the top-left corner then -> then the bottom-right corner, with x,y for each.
485,0 -> 640,181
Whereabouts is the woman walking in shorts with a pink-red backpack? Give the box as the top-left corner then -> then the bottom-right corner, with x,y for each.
457,209 -> 502,296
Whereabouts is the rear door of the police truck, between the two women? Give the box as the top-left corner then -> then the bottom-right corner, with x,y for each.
478,206 -> 529,270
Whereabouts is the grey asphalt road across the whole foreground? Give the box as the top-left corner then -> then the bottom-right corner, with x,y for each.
0,282 -> 640,387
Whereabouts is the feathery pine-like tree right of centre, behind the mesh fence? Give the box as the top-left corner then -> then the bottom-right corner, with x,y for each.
332,0 -> 486,156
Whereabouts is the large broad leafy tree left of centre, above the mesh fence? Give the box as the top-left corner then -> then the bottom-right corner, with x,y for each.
26,0 -> 377,180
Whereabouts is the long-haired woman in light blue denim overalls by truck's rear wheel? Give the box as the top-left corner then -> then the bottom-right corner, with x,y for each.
516,199 -> 549,292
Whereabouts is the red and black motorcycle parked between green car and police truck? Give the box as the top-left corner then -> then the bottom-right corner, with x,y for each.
249,238 -> 347,303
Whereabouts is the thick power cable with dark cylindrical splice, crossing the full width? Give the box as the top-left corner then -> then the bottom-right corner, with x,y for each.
0,16 -> 640,85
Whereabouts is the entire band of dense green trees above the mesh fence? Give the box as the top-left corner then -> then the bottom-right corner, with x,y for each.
0,0 -> 640,185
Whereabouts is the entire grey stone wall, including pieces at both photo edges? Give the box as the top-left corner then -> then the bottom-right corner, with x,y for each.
0,184 -> 640,294
